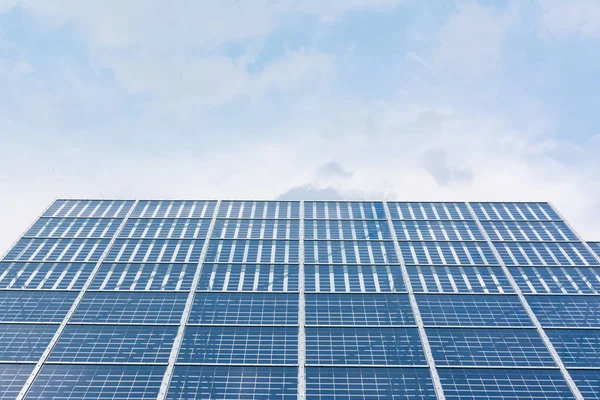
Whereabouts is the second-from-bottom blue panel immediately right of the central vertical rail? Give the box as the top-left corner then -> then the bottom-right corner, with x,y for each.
306,327 -> 427,366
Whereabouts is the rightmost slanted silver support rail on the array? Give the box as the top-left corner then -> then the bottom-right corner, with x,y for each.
465,202 -> 585,400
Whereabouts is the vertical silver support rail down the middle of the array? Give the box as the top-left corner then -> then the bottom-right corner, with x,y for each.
298,201 -> 306,400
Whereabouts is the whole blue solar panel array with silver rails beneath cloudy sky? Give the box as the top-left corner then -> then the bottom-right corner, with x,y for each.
0,200 -> 600,400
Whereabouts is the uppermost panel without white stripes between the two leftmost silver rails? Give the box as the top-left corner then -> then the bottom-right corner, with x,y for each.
71,292 -> 187,324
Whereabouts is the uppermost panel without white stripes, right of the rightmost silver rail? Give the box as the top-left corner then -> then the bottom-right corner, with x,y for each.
527,296 -> 600,328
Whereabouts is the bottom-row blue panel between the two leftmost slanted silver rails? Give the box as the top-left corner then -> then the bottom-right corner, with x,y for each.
27,365 -> 165,400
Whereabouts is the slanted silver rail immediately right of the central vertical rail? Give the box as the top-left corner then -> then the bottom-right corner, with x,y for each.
383,201 -> 446,400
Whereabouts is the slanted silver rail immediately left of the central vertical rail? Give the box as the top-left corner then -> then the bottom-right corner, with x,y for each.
157,200 -> 221,400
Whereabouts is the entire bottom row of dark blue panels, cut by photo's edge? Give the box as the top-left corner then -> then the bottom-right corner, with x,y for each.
5,364 -> 600,400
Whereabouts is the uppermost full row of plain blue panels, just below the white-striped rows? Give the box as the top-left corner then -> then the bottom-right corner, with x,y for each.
0,291 -> 600,328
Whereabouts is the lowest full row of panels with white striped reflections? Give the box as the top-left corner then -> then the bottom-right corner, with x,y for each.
0,262 -> 600,294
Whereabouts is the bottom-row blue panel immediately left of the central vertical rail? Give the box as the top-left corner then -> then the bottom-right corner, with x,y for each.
167,365 -> 298,400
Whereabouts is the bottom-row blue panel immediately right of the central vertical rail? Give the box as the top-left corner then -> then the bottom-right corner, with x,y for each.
306,367 -> 436,400
